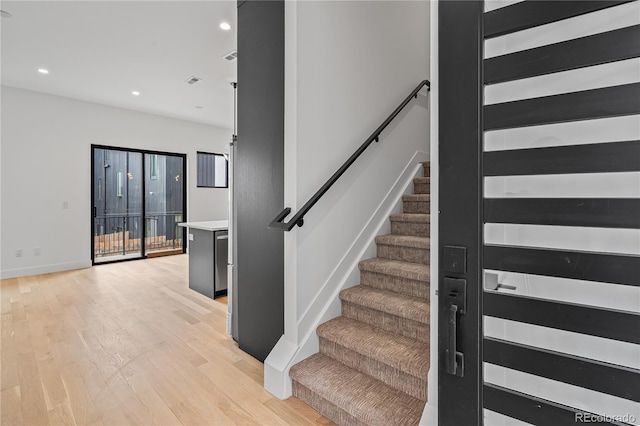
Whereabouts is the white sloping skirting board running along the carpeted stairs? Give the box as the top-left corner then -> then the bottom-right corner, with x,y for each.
264,151 -> 429,399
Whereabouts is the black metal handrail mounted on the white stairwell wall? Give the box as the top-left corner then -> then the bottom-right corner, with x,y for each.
269,80 -> 431,231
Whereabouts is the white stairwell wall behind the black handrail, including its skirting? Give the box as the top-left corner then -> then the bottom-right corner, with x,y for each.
265,1 -> 429,397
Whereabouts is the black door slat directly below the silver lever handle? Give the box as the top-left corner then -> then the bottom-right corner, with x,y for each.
483,292 -> 640,344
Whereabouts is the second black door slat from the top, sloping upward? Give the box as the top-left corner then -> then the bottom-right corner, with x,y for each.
484,25 -> 640,84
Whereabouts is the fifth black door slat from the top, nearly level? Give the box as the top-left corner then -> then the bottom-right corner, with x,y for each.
484,198 -> 640,229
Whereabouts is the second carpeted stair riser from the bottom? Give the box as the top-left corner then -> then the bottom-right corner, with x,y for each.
320,337 -> 427,401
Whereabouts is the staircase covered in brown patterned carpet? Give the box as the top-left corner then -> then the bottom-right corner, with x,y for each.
289,163 -> 430,426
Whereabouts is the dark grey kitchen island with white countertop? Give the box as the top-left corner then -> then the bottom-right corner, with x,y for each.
178,220 -> 229,299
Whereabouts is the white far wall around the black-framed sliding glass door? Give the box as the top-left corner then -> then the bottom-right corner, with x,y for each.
0,86 -> 231,278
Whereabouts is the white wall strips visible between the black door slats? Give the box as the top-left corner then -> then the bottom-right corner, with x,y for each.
484,2 -> 640,425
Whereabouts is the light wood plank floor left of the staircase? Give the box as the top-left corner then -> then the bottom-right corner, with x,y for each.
0,255 -> 332,425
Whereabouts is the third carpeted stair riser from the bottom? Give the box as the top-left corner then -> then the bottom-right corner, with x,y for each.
342,300 -> 429,343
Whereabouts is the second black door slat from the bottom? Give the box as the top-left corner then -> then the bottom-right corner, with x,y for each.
483,336 -> 640,402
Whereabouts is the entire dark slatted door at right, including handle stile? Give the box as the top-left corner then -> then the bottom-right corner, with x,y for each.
438,1 -> 640,426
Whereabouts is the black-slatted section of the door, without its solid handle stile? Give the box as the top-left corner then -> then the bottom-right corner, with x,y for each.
482,1 -> 640,426
